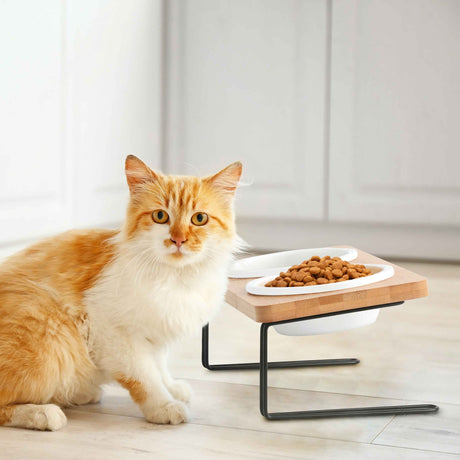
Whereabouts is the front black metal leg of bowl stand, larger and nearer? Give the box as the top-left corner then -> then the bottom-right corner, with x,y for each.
260,323 -> 439,420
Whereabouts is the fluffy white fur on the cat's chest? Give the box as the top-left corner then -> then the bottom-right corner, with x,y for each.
85,252 -> 230,357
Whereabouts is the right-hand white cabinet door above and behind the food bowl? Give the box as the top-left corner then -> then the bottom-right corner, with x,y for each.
329,0 -> 460,225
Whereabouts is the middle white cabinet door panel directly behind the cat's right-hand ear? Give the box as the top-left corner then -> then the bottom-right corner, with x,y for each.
166,0 -> 327,220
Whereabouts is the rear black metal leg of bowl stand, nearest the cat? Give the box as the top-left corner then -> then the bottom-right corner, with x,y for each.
201,324 -> 359,371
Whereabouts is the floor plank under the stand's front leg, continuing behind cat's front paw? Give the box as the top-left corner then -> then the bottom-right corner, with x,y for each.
70,380 -> 422,442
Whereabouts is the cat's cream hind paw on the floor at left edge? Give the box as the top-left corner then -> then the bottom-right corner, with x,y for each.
0,404 -> 67,431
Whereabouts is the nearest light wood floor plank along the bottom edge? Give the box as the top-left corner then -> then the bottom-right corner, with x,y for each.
0,410 -> 458,460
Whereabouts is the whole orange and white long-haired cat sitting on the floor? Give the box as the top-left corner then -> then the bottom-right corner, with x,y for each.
0,155 -> 242,431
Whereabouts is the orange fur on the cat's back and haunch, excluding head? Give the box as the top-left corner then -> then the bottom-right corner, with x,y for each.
0,230 -> 115,413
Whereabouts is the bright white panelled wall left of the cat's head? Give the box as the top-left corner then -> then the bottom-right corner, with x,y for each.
0,0 -> 162,254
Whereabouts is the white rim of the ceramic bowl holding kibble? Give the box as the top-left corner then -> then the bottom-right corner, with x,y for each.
246,264 -> 394,296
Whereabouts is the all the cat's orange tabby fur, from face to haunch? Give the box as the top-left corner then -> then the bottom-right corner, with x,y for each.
0,156 -> 241,429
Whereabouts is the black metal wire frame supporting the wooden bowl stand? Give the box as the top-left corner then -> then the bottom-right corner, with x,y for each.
201,302 -> 439,420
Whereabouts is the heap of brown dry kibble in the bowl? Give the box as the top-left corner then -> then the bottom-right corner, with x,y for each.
265,256 -> 371,287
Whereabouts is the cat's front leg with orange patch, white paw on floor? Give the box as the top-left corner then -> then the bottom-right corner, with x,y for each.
112,346 -> 188,425
